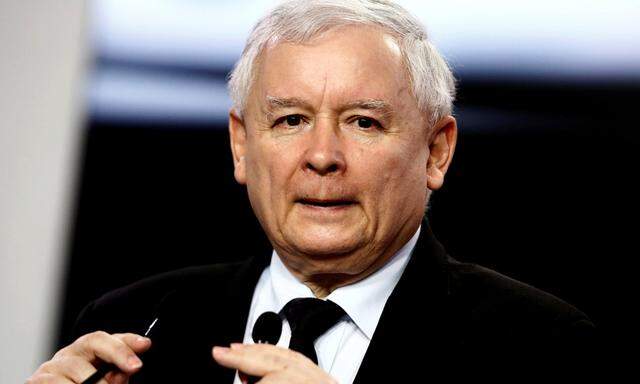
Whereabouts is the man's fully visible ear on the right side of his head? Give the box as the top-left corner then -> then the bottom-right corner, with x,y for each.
427,116 -> 458,190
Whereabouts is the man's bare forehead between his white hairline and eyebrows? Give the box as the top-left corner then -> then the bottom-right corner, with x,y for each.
252,26 -> 409,107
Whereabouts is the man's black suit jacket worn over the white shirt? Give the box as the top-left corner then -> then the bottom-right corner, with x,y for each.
76,223 -> 597,384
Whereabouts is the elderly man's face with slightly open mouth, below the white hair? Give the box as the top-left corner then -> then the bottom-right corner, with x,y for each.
230,26 -> 456,276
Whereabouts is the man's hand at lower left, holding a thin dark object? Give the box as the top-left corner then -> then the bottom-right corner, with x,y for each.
27,331 -> 151,384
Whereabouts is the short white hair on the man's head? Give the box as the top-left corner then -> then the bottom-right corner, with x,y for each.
228,0 -> 456,125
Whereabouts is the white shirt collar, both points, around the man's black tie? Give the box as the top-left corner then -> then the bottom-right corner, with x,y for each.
270,227 -> 420,340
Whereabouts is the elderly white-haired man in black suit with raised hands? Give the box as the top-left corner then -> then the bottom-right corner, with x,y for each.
30,0 -> 593,383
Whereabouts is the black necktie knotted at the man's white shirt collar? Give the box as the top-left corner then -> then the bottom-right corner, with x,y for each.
282,298 -> 346,364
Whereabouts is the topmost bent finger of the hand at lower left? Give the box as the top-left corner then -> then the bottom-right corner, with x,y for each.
61,331 -> 142,373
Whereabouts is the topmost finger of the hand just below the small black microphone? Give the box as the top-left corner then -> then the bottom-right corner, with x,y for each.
213,344 -> 304,377
